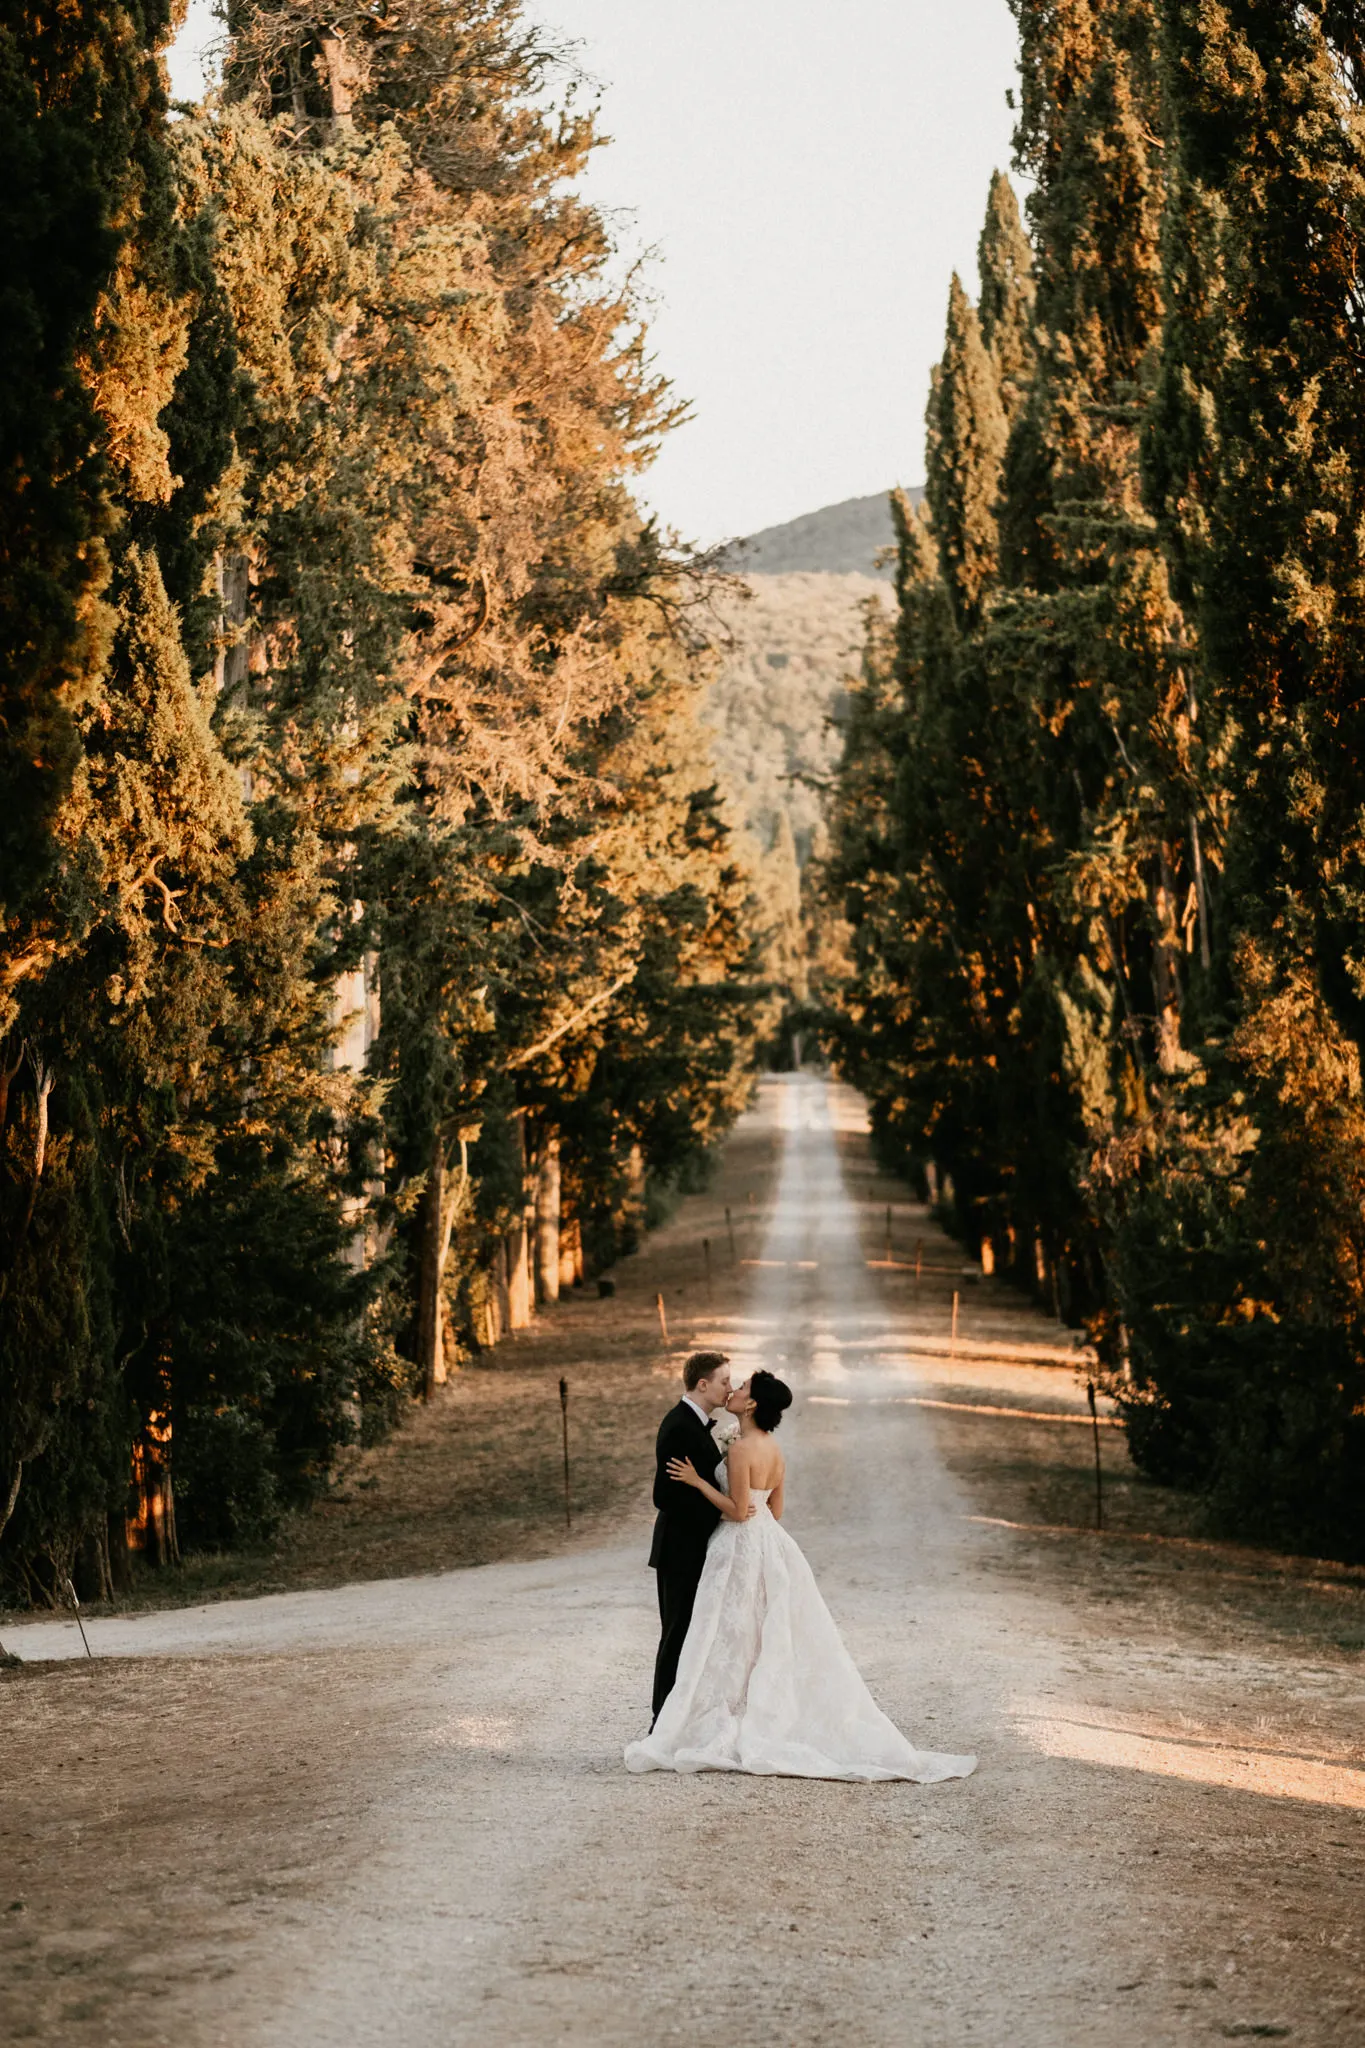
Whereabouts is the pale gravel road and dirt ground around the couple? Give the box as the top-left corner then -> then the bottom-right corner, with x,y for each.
0,1077 -> 1365,2048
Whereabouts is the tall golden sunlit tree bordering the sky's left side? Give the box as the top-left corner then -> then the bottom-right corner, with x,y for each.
217,4 -> 765,1386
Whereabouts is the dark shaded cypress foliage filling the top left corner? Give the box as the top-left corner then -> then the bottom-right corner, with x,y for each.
0,0 -> 168,1030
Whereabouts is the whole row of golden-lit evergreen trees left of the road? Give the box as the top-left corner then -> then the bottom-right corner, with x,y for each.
0,0 -> 761,1597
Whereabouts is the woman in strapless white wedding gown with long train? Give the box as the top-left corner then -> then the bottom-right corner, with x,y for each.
626,1372 -> 976,1784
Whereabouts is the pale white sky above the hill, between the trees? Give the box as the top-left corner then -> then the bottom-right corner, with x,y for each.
172,0 -> 1015,543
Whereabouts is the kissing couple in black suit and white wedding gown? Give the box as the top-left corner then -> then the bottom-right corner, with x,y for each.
626,1352 -> 976,1784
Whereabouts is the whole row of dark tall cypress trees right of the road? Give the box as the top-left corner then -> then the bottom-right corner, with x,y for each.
829,0 -> 1365,1556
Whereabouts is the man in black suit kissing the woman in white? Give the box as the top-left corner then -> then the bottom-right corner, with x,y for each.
649,1352 -> 731,1726
